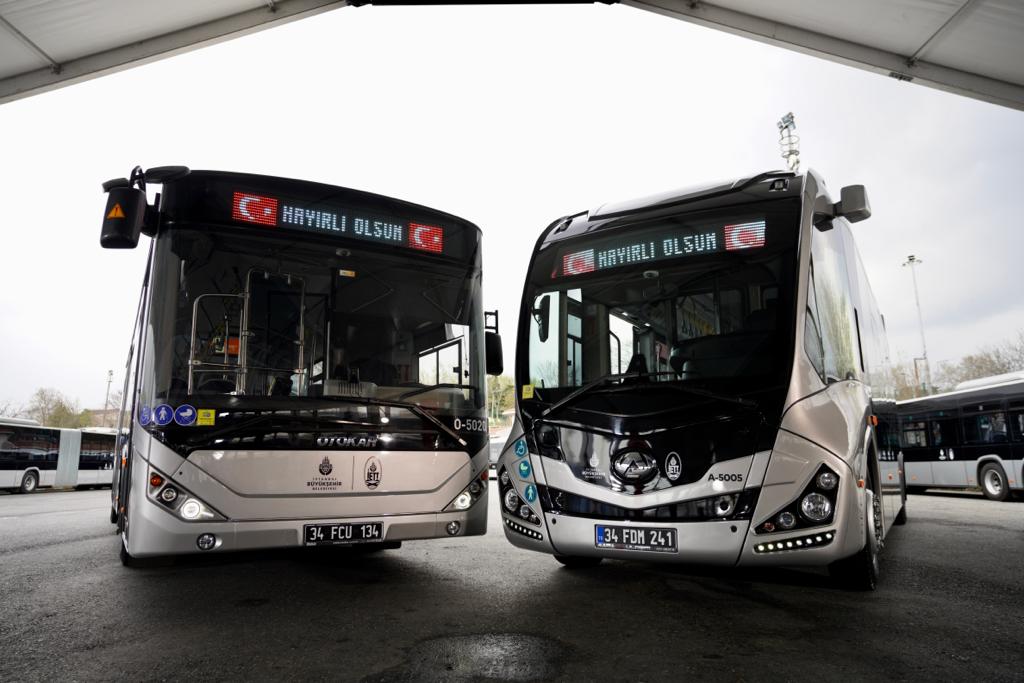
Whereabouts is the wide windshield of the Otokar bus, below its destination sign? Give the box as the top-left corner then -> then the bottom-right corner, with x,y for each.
141,225 -> 484,424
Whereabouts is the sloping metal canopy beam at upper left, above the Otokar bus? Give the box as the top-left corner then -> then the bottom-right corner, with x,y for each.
0,0 -> 350,103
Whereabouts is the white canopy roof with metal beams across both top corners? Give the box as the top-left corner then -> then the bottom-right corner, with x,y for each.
0,0 -> 1024,110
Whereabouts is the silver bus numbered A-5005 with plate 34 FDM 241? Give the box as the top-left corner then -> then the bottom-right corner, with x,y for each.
498,172 -> 905,589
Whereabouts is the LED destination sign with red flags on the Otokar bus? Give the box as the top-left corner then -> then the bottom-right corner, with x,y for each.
231,193 -> 444,254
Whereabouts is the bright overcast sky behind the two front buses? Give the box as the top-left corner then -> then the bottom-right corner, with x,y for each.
0,5 -> 1024,408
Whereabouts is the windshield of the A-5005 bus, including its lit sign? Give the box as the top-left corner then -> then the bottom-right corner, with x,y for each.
518,200 -> 800,411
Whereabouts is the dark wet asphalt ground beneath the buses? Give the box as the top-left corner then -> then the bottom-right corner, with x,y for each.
0,484 -> 1024,681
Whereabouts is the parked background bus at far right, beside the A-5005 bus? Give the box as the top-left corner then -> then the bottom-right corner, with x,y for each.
899,373 -> 1024,501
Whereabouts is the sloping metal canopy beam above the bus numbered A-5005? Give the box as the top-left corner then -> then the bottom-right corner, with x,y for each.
622,0 -> 1024,111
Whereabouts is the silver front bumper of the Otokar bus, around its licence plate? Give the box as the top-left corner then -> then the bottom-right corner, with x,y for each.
126,496 -> 487,557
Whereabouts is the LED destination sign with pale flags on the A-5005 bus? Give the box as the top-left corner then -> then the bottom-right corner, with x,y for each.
556,219 -> 765,278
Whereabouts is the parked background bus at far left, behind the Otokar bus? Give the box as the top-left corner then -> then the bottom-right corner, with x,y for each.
0,419 -> 117,494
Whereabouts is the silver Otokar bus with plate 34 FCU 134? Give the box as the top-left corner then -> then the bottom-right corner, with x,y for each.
101,167 -> 501,565
